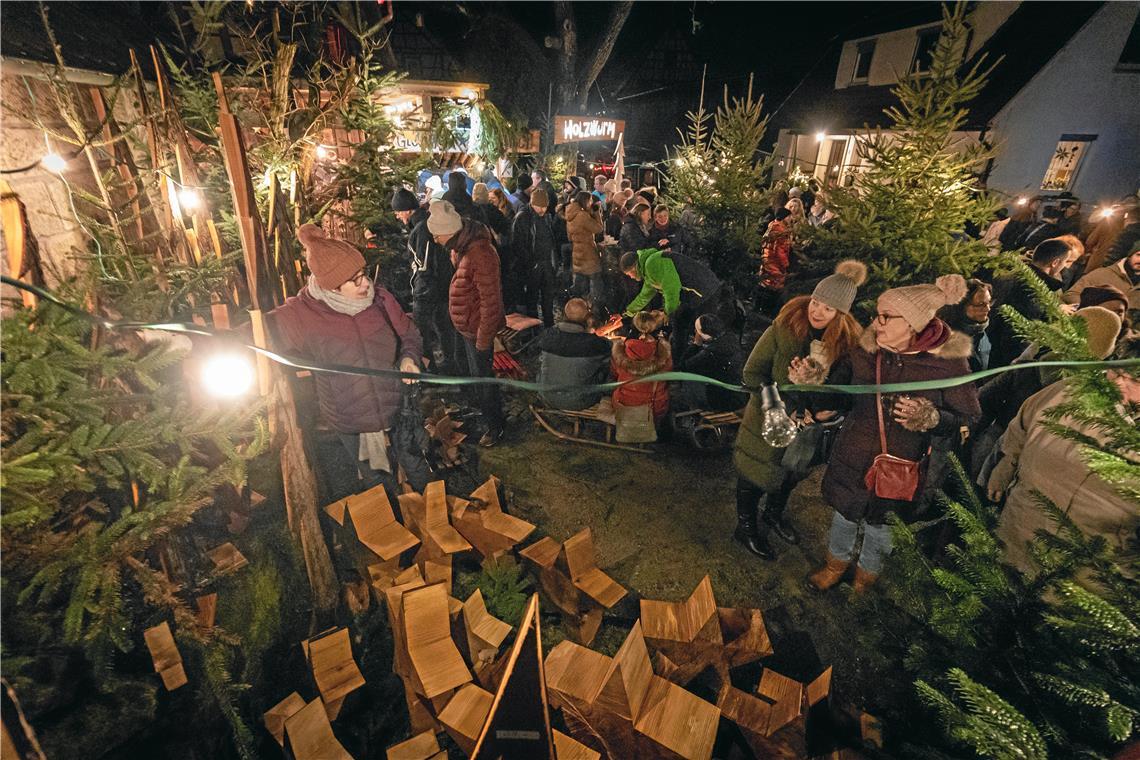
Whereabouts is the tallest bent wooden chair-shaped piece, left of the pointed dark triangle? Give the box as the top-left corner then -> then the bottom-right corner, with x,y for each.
402,583 -> 471,698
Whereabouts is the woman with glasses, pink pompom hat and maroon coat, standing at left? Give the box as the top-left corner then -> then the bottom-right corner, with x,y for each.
269,224 -> 423,493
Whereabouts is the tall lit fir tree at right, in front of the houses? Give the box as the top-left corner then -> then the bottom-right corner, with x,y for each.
806,2 -> 996,297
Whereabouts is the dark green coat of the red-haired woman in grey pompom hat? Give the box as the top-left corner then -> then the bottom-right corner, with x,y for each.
732,325 -> 850,491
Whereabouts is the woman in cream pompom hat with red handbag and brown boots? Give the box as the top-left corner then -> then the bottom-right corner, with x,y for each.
809,275 -> 982,591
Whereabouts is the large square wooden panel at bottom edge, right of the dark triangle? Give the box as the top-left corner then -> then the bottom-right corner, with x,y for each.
634,676 -> 720,760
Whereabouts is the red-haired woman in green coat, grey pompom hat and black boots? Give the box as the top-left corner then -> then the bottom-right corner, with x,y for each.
733,261 -> 866,559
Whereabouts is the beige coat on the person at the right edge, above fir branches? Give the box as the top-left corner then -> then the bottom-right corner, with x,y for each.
990,381 -> 1140,571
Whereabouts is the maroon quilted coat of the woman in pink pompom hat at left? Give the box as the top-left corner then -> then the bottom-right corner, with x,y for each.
268,286 -> 423,433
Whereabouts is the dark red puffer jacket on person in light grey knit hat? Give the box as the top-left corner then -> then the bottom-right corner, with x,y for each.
447,219 -> 506,351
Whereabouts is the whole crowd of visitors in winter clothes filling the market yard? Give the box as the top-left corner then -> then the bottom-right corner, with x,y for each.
270,170 -> 1140,590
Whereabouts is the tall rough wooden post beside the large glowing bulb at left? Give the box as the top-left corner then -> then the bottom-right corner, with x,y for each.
214,73 -> 336,619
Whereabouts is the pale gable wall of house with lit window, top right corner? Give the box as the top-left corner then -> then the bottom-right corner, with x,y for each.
990,2 -> 1140,205
